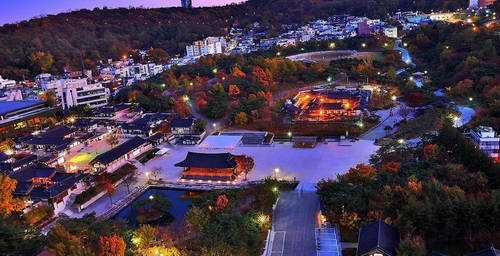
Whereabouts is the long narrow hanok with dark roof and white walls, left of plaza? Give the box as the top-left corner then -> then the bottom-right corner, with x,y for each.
90,136 -> 151,172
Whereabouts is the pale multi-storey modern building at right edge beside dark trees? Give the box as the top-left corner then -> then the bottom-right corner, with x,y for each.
470,126 -> 500,162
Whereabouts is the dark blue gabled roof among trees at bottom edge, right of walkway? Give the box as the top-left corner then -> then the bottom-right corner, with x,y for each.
356,219 -> 400,256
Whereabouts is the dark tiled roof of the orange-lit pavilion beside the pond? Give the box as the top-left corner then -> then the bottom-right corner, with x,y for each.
174,152 -> 236,168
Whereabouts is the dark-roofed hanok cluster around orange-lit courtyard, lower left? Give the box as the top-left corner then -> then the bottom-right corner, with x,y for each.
9,165 -> 90,215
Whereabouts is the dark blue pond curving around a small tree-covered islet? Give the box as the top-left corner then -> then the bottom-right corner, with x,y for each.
112,188 -> 199,227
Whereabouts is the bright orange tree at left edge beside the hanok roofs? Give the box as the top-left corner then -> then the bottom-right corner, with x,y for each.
0,175 -> 24,217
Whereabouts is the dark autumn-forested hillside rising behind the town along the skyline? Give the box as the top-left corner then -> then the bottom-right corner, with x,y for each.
0,0 -> 467,79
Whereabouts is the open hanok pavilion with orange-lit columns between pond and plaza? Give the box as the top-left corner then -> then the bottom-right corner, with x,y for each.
174,152 -> 240,181
